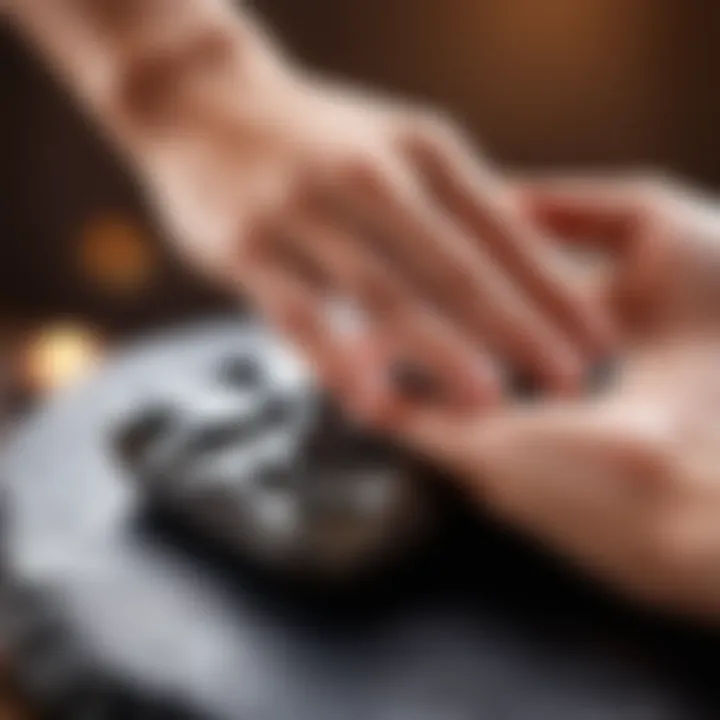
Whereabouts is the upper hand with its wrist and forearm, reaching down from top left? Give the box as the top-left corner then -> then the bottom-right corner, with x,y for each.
5,0 -> 612,408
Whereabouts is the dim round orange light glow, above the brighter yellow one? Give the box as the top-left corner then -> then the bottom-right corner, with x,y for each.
79,215 -> 157,295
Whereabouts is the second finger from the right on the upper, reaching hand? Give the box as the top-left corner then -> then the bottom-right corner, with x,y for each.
330,155 -> 583,392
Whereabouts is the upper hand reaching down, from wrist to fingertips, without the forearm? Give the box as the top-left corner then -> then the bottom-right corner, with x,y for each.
131,49 -> 609,407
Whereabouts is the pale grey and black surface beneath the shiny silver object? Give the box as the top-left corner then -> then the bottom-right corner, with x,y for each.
2,321 -> 720,720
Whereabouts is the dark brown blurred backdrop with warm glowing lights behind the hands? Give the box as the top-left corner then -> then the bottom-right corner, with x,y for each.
0,0 -> 720,410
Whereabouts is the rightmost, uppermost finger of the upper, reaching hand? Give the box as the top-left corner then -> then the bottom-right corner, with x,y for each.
406,128 -> 612,356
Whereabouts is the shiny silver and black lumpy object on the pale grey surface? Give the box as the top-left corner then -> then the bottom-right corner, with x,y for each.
114,329 -> 433,581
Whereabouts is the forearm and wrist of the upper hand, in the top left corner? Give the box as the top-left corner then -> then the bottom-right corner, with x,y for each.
4,0 -> 292,152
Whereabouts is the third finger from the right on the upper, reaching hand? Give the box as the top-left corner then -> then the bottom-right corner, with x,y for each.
283,215 -> 500,406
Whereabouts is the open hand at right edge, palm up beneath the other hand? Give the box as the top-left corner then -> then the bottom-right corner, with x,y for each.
388,181 -> 720,619
